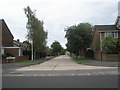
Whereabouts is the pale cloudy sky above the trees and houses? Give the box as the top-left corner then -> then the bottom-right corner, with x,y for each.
0,0 -> 119,48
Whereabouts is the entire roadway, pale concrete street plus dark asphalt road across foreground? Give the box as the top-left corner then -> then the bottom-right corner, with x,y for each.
3,56 -> 118,88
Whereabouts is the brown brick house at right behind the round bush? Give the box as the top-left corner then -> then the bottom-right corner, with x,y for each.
92,16 -> 120,61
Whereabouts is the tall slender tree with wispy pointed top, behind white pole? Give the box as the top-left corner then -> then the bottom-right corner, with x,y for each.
24,6 -> 47,59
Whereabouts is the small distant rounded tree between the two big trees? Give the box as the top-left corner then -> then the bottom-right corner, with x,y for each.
51,41 -> 62,55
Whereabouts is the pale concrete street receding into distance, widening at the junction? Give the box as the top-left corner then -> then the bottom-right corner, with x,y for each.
17,55 -> 117,71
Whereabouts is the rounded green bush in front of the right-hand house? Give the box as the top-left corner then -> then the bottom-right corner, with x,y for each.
102,36 -> 120,54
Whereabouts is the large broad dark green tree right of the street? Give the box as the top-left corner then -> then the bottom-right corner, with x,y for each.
65,23 -> 92,55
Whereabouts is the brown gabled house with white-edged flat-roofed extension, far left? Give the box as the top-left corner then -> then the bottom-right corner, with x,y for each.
0,19 -> 22,57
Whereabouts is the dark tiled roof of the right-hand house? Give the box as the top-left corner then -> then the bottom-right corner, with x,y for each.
94,25 -> 120,31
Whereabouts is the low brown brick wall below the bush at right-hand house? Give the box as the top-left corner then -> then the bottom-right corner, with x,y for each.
95,53 -> 120,61
